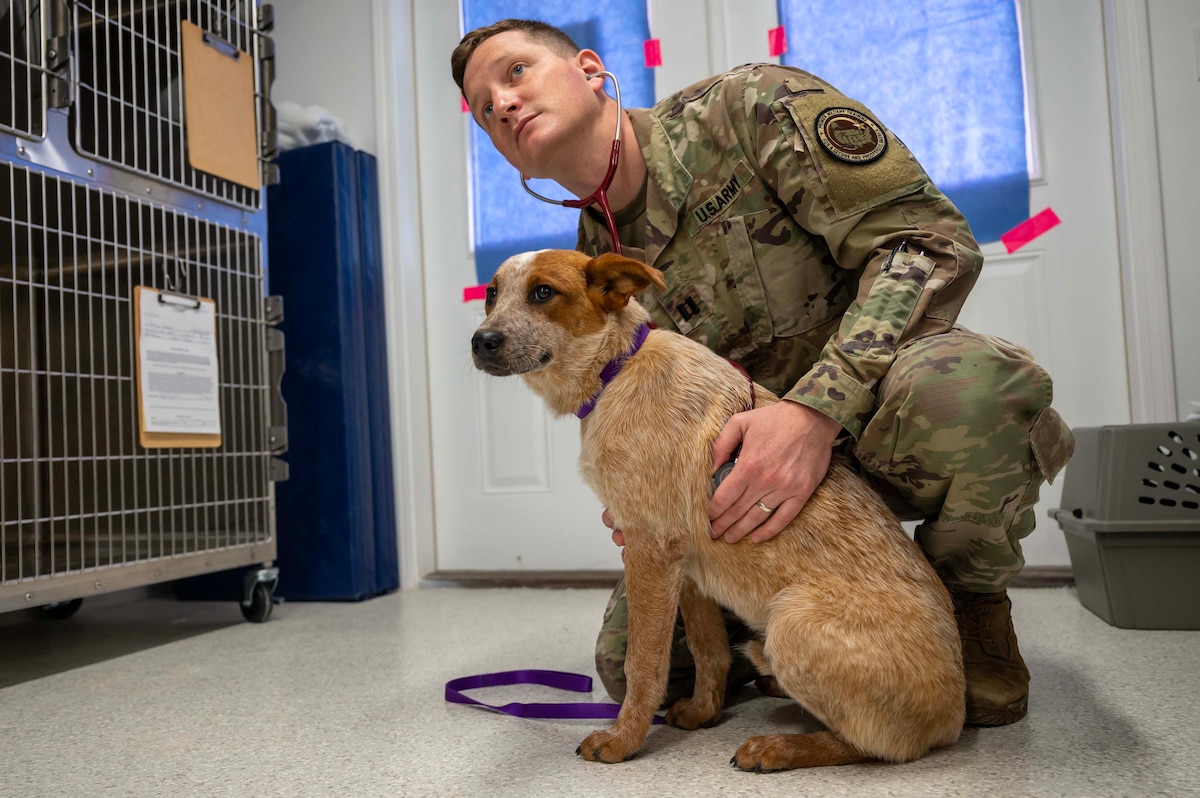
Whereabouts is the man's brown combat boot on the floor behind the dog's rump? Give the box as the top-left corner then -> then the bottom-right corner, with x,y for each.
950,590 -> 1030,726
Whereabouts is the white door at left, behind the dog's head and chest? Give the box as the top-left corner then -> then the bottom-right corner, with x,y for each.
413,2 -> 620,571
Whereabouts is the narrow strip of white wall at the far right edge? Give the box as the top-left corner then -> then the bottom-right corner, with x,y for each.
1148,0 -> 1200,418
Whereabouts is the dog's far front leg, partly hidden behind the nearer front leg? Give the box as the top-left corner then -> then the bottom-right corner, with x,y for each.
667,580 -> 733,731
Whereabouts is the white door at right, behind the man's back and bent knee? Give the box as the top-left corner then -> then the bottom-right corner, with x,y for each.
959,0 -> 1129,565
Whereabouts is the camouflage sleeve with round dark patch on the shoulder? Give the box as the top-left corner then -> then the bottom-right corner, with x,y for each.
743,71 -> 983,437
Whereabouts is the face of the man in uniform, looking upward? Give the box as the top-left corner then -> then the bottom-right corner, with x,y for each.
463,30 -> 602,178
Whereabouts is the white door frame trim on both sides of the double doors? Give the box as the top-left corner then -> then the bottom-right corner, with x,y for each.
381,0 -> 1177,589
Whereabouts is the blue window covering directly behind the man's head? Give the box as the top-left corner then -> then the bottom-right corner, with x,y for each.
463,0 -> 654,283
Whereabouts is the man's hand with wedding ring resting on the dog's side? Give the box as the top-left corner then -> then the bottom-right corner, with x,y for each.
705,401 -> 841,544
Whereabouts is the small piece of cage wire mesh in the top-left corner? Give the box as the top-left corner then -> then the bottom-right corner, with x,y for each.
0,0 -> 48,138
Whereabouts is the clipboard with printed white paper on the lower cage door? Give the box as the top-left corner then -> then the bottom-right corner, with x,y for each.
133,286 -> 221,449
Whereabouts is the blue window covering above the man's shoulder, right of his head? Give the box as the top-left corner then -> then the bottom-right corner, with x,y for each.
779,0 -> 1030,244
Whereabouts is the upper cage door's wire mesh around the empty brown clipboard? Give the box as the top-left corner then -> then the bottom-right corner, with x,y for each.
71,0 -> 274,209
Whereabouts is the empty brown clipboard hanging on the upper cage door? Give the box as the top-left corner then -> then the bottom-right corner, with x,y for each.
180,20 -> 263,190
